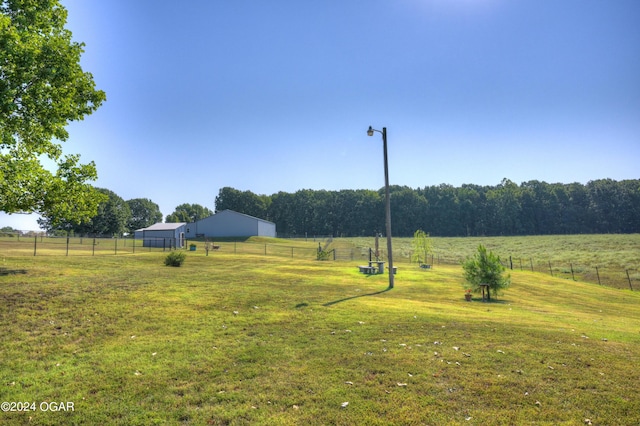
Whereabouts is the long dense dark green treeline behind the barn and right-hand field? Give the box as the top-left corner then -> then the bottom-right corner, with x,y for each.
215,179 -> 640,237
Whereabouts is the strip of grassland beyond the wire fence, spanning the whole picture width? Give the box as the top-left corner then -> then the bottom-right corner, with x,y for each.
0,234 -> 640,291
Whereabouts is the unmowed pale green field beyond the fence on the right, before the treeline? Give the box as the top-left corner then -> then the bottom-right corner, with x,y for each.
333,234 -> 640,291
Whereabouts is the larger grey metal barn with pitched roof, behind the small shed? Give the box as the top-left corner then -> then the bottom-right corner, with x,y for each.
186,210 -> 276,238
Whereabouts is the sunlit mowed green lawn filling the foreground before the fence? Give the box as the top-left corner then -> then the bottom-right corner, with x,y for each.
0,251 -> 640,425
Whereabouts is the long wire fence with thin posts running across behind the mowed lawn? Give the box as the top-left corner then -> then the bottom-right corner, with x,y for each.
0,233 -> 640,291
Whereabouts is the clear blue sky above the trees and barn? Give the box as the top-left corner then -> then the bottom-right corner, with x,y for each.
0,0 -> 640,229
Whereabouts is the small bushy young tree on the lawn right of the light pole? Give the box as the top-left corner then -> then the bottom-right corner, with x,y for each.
462,244 -> 511,298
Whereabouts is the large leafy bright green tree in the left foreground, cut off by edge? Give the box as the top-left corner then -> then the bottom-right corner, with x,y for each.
0,0 -> 106,224
